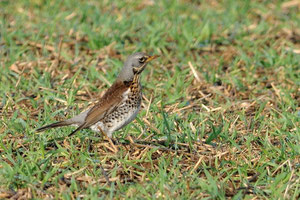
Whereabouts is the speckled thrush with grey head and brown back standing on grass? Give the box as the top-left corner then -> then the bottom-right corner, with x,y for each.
37,52 -> 158,138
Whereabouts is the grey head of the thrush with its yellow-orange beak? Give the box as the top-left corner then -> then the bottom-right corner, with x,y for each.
118,52 -> 158,81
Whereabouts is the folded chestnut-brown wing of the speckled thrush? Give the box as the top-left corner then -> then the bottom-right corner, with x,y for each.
81,82 -> 129,129
